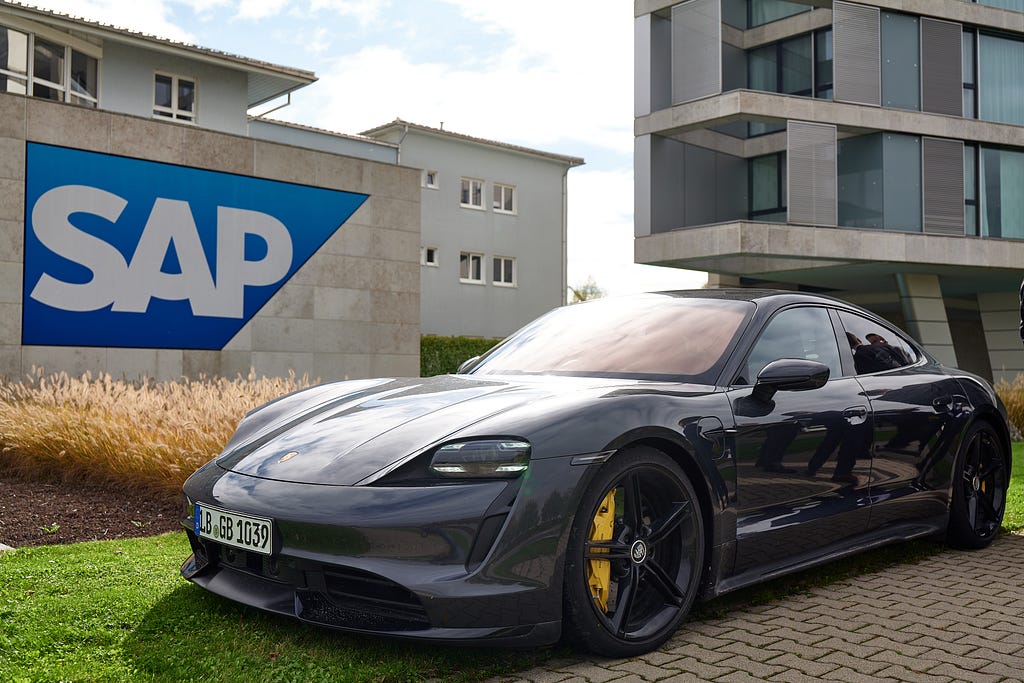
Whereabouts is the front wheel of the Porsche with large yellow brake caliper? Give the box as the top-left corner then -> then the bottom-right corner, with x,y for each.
563,446 -> 705,657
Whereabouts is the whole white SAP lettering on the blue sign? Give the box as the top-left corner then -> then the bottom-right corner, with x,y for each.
30,185 -> 292,318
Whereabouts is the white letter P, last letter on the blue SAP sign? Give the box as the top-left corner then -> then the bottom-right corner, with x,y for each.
207,207 -> 292,317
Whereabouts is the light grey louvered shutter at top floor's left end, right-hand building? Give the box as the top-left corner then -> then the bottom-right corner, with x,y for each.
672,0 -> 722,104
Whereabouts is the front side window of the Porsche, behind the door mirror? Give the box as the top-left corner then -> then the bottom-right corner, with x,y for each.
736,306 -> 843,384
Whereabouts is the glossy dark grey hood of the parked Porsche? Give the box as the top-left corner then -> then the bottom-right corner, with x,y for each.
217,375 -> 622,485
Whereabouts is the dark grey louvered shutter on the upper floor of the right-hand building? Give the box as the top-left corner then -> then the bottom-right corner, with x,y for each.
921,17 -> 964,116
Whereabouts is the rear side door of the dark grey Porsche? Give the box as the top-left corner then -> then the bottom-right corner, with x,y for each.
839,311 -> 971,529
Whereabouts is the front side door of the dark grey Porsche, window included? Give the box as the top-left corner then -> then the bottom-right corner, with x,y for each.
729,306 -> 871,574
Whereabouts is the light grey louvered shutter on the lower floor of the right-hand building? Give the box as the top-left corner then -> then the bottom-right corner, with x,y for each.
786,121 -> 838,225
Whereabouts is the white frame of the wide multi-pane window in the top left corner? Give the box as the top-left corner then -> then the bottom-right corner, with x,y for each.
0,23 -> 102,109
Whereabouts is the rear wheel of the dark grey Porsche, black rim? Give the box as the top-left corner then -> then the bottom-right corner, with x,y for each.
946,422 -> 1009,548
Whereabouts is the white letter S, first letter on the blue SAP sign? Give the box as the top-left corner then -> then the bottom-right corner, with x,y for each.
30,185 -> 128,311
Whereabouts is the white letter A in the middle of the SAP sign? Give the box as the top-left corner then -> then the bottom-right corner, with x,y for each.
113,198 -> 218,317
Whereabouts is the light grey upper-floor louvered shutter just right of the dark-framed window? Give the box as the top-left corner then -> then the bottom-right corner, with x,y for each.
833,0 -> 880,105
